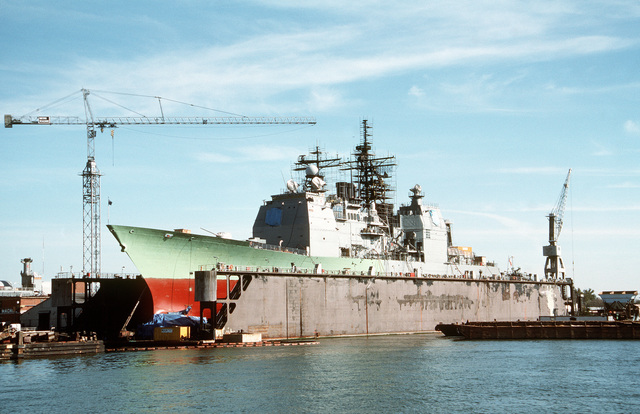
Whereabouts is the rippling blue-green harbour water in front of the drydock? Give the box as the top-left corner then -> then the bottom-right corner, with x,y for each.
0,335 -> 640,413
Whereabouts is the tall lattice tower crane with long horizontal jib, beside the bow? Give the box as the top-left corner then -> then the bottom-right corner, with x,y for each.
4,89 -> 316,277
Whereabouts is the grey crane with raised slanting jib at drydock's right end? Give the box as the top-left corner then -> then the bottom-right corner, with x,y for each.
542,168 -> 571,280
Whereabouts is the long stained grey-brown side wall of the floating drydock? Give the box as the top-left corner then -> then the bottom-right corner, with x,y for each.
225,275 -> 566,338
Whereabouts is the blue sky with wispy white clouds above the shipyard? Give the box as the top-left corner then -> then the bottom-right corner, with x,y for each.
0,0 -> 640,292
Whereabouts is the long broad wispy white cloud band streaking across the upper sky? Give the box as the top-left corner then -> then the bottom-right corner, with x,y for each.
41,2 -> 630,112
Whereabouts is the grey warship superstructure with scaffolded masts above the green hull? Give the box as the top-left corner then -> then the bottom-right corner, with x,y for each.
253,120 -> 492,277
